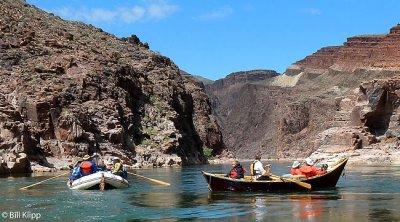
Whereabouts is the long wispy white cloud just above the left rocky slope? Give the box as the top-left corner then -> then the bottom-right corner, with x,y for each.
50,0 -> 179,23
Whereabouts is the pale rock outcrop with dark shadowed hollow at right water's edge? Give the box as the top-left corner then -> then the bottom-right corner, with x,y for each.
311,76 -> 400,164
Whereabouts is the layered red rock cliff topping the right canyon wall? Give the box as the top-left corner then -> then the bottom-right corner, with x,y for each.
295,24 -> 400,71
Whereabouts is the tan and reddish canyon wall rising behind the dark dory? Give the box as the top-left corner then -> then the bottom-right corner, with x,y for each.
206,25 -> 400,163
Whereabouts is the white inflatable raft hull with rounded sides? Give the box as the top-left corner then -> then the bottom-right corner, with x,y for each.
67,172 -> 129,190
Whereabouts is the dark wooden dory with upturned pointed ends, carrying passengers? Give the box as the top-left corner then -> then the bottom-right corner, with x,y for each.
202,158 -> 348,192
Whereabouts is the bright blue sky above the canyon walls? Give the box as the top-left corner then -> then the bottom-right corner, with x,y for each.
27,0 -> 400,80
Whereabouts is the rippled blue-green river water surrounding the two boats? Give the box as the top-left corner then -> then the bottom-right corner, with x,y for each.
0,163 -> 400,221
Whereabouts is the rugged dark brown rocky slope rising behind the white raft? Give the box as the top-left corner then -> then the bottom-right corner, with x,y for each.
0,0 -> 222,173
